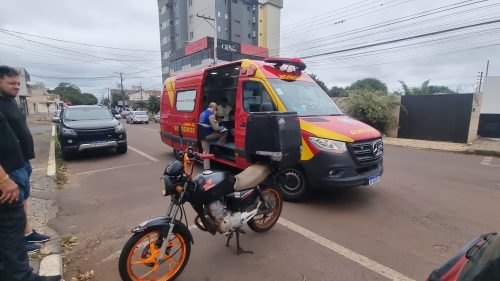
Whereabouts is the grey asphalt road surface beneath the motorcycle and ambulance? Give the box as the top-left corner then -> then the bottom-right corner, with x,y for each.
50,123 -> 500,281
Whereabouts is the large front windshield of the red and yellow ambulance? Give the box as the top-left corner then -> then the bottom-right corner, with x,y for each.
269,79 -> 342,116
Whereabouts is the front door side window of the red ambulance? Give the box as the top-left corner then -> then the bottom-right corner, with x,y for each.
243,81 -> 276,113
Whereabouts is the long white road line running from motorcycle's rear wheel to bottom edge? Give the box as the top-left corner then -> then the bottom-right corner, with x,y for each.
278,218 -> 415,281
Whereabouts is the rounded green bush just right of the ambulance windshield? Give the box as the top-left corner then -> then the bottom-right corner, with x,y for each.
347,89 -> 401,132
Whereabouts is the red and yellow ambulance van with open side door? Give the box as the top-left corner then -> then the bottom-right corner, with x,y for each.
160,58 -> 383,200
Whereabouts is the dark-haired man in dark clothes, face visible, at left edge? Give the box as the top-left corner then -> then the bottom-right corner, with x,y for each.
0,65 -> 50,252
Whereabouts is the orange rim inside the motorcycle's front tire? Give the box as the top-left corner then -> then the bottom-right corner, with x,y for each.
127,231 -> 187,281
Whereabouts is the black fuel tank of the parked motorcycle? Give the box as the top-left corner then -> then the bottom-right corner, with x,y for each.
191,170 -> 236,205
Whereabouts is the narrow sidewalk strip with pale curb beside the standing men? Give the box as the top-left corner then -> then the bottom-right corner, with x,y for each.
28,119 -> 63,276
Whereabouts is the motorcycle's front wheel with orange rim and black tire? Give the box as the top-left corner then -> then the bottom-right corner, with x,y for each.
118,227 -> 191,281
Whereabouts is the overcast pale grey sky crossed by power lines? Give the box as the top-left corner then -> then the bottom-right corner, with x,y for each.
0,0 -> 500,97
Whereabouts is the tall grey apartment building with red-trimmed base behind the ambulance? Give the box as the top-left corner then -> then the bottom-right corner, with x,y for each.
158,0 -> 283,80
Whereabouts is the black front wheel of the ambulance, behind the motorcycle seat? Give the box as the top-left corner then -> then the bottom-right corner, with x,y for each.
280,167 -> 307,202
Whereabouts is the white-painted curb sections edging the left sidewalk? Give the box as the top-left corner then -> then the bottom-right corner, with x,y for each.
38,126 -> 63,276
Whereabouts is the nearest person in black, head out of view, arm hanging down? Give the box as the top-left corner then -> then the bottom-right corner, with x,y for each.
0,110 -> 61,281
